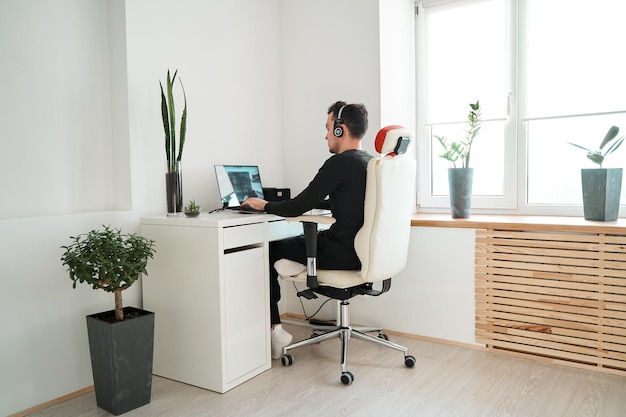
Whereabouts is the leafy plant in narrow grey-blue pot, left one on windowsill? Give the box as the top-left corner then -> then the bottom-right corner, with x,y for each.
435,100 -> 482,218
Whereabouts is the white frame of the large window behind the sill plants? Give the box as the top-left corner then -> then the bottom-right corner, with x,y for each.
415,0 -> 626,217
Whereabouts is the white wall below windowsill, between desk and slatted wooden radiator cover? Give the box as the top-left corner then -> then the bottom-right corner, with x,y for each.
282,227 -> 475,345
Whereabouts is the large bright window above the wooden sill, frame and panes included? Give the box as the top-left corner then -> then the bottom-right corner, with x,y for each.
417,0 -> 626,215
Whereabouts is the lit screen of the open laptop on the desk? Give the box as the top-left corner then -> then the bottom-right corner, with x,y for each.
215,165 -> 264,208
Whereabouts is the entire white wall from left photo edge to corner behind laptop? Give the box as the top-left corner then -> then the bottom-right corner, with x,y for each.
0,0 -> 283,415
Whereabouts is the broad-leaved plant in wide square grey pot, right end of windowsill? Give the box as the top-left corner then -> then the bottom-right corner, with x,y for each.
568,126 -> 624,221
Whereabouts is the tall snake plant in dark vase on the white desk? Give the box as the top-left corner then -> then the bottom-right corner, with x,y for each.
159,70 -> 187,213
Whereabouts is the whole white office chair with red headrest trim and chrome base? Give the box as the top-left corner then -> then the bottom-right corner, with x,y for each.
276,126 -> 416,385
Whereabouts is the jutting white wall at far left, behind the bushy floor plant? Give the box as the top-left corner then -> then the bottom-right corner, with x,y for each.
0,0 -> 141,415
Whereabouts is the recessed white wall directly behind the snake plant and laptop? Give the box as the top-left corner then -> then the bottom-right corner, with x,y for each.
126,0 -> 283,213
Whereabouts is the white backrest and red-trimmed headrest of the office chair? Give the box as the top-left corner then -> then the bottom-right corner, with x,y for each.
354,126 -> 416,282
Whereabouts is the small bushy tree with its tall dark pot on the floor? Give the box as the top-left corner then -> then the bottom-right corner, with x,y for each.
61,226 -> 155,415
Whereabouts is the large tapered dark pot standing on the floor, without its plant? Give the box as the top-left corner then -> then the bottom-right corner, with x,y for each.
87,307 -> 154,416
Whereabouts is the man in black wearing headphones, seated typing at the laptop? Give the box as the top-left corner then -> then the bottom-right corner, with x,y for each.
242,101 -> 372,359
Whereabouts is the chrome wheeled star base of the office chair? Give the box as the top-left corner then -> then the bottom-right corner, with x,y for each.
282,300 -> 415,385
